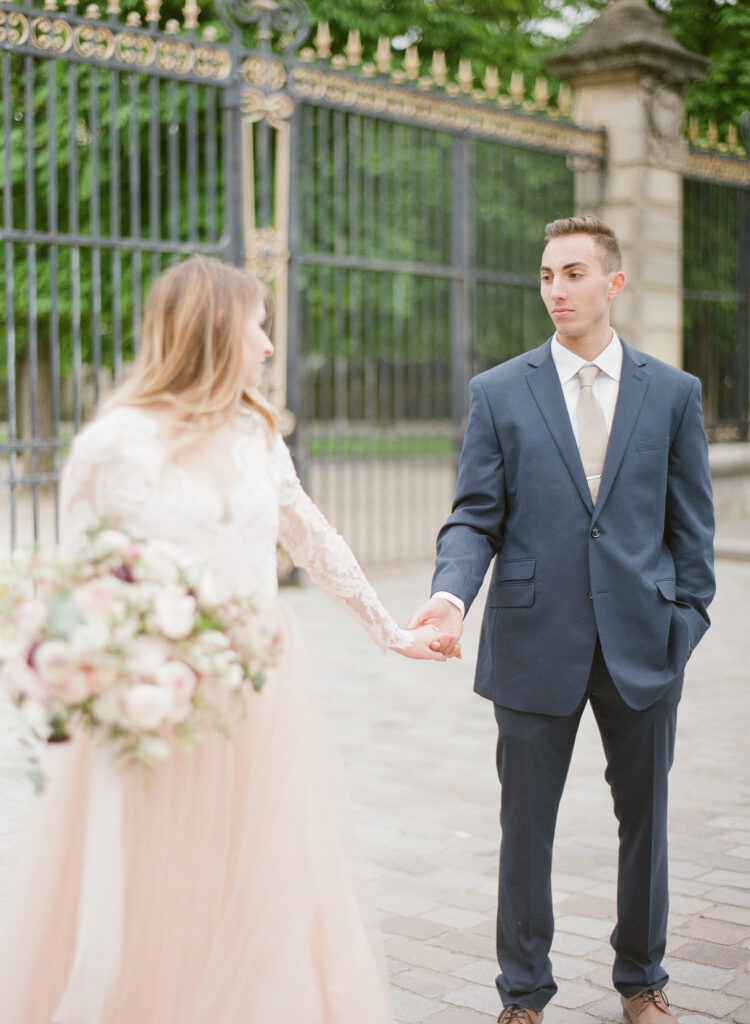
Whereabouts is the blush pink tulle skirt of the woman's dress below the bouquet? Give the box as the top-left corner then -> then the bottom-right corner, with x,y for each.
0,602 -> 391,1024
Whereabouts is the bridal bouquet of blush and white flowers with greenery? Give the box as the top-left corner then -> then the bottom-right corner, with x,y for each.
0,527 -> 278,778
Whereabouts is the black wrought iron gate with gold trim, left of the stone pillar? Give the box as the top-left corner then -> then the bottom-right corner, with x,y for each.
0,0 -> 603,562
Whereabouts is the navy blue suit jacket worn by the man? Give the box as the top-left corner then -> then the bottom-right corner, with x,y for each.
432,339 -> 715,715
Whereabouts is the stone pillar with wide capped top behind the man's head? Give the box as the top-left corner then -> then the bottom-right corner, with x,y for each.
547,0 -> 708,366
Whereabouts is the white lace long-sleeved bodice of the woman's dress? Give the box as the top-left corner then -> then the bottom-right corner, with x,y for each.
61,407 -> 410,648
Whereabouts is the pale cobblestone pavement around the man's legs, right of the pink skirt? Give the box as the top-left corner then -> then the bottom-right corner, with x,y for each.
285,561 -> 750,1024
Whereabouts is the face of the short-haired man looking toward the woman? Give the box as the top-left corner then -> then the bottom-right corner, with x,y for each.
540,234 -> 625,342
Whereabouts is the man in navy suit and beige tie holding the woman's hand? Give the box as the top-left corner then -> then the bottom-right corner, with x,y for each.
410,216 -> 714,1024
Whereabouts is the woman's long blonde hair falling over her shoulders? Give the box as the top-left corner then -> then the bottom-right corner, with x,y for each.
106,256 -> 279,440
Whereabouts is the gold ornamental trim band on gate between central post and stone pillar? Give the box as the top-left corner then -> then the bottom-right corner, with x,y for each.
290,67 -> 606,160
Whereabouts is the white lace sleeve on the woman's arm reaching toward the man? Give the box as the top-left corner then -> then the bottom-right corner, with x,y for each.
274,437 -> 412,650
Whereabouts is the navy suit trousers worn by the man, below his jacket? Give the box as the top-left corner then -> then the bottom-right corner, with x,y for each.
495,641 -> 682,1011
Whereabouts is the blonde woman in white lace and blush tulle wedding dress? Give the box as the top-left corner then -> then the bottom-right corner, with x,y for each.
0,251 -> 456,1024
